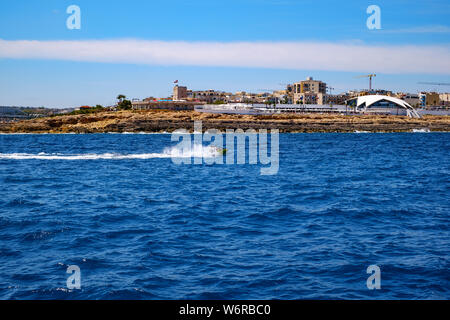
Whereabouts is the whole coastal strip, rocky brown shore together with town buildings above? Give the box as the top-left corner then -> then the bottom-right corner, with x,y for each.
0,74 -> 450,133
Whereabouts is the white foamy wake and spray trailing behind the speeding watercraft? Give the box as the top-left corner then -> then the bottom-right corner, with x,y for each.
0,144 -> 222,161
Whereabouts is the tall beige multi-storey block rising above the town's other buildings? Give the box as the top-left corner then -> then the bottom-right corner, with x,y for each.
287,77 -> 327,104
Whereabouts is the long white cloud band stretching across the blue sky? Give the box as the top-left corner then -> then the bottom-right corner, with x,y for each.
0,39 -> 450,74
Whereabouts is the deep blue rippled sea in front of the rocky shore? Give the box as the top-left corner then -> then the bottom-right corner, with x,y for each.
0,133 -> 450,299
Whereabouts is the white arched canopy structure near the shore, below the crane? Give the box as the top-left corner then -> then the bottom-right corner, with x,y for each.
348,95 -> 420,118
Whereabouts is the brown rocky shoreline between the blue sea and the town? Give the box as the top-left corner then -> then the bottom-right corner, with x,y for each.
0,110 -> 450,133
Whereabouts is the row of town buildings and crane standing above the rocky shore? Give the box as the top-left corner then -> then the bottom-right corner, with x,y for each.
125,74 -> 450,118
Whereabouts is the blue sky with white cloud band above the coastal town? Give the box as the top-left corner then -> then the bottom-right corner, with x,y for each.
0,0 -> 450,107
